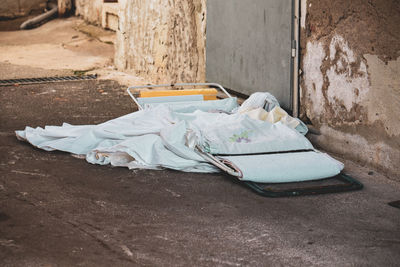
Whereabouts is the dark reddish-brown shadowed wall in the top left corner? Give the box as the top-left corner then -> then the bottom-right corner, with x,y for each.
0,0 -> 47,19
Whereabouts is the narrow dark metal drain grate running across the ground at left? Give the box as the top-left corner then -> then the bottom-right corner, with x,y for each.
0,74 -> 97,86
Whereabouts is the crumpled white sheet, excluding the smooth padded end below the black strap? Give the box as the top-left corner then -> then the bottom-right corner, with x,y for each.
16,93 -> 312,176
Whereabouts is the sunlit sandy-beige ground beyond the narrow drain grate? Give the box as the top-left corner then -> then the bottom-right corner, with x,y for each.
0,18 -> 114,79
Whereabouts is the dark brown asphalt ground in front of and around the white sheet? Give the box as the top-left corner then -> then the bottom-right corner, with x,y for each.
0,81 -> 400,266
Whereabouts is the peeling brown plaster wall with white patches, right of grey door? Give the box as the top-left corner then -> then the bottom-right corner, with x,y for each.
301,0 -> 400,180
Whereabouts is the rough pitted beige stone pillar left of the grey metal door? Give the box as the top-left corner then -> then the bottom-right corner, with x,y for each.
115,0 -> 206,83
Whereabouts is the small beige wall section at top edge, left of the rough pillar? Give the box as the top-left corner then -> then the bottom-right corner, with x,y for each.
75,0 -> 103,25
